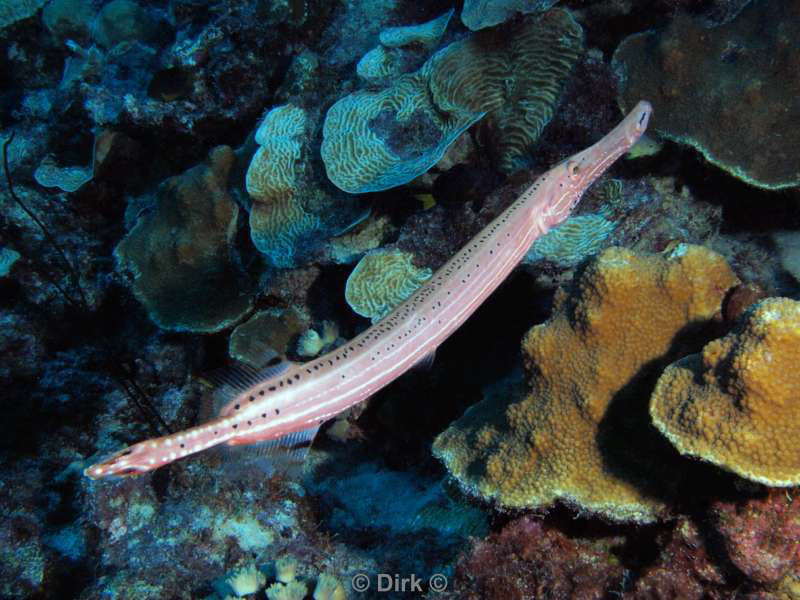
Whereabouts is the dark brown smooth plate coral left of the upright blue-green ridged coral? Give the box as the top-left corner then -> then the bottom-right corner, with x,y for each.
114,146 -> 252,332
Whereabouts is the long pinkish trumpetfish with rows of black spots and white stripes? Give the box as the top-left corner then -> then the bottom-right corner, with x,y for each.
84,101 -> 653,479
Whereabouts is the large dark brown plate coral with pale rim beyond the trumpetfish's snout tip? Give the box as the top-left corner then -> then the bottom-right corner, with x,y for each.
614,0 -> 800,188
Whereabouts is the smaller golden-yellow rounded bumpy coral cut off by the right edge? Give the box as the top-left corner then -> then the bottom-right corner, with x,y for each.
650,298 -> 800,486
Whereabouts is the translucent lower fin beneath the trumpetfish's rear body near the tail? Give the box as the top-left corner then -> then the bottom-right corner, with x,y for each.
225,424 -> 319,476
